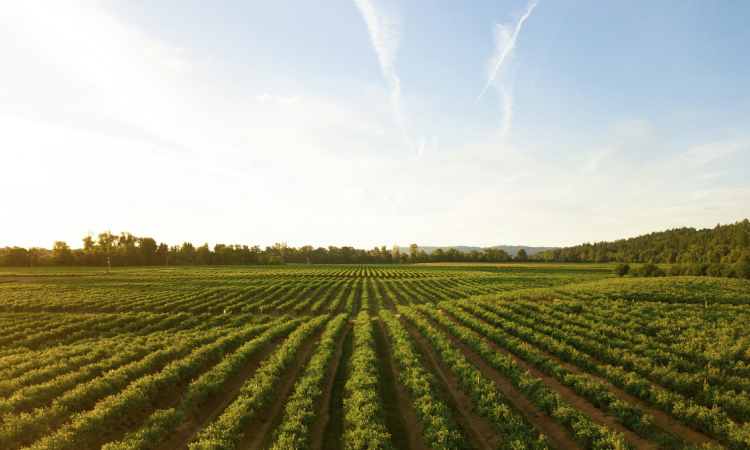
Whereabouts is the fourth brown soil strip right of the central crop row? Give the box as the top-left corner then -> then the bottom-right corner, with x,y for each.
436,311 -> 659,450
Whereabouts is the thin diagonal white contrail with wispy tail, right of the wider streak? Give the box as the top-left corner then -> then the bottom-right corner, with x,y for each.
476,0 -> 539,139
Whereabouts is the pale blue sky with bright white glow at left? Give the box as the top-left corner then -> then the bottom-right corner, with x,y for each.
0,0 -> 750,248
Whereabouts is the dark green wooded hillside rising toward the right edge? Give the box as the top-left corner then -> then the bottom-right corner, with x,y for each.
532,219 -> 750,266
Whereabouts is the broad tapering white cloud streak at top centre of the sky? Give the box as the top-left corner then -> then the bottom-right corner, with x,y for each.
355,0 -> 414,148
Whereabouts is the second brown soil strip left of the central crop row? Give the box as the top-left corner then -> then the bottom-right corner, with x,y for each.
236,329 -> 324,450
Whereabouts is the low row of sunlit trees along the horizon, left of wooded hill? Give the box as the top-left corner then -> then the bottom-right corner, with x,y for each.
0,231 -> 528,267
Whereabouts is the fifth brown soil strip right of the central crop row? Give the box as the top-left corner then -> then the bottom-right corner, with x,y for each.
464,310 -> 721,446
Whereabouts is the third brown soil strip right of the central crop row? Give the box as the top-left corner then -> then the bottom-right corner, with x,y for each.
423,316 -> 578,450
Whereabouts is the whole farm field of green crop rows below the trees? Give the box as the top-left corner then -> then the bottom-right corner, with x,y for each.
0,263 -> 750,450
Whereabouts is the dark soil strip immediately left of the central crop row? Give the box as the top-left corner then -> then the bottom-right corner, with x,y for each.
310,322 -> 354,450
